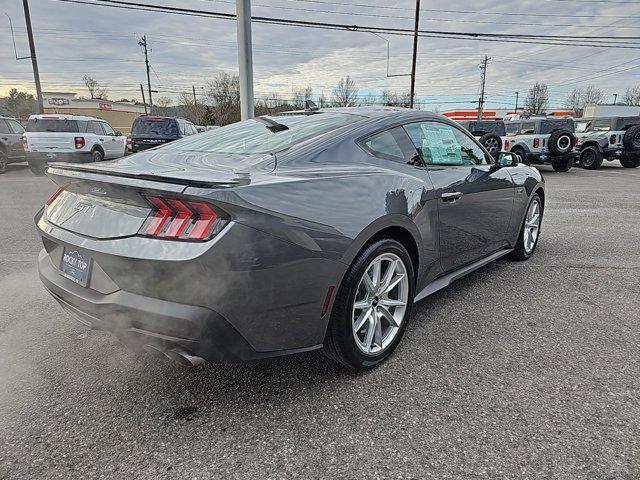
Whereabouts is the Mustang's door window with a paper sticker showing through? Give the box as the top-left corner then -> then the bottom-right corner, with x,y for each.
404,122 -> 489,166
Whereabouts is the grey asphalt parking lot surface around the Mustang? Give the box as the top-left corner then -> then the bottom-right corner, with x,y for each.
0,162 -> 640,480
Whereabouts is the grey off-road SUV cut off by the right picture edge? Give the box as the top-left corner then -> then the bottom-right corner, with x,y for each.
576,117 -> 640,170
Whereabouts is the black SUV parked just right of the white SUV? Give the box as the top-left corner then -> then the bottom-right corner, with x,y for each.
128,115 -> 198,153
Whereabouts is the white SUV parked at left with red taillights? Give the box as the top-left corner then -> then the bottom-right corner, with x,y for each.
22,114 -> 127,175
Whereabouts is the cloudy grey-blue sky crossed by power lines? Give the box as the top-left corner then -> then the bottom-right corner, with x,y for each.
0,0 -> 640,110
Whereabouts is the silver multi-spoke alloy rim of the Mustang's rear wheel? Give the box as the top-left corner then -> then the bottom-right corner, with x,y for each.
351,253 -> 409,355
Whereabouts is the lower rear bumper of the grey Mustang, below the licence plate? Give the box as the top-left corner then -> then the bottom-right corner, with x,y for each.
38,249 -> 319,362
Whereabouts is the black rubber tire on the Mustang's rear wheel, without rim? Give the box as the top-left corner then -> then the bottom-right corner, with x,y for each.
323,237 -> 415,370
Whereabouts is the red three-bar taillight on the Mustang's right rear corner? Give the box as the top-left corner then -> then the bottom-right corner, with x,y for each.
138,195 -> 226,240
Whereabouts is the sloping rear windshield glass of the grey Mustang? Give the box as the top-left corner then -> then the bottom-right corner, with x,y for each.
162,113 -> 364,154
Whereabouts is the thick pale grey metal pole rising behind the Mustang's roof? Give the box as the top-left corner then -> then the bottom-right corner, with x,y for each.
236,0 -> 254,120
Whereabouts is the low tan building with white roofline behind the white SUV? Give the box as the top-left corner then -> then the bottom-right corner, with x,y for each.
42,92 -> 145,134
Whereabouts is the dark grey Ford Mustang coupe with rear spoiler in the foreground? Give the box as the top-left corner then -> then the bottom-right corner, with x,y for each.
35,108 -> 545,369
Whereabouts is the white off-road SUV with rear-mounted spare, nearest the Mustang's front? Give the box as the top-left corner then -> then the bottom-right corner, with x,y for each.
502,117 -> 578,172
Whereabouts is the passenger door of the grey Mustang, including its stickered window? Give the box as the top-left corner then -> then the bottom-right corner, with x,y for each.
404,120 -> 514,272
